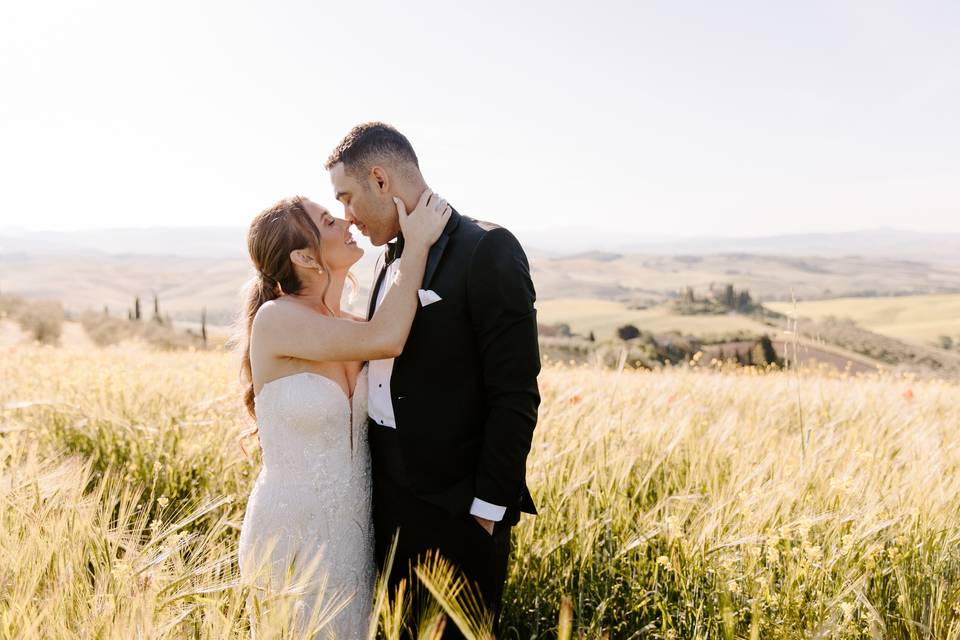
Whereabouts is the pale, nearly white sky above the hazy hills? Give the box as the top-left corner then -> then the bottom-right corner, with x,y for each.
0,0 -> 960,237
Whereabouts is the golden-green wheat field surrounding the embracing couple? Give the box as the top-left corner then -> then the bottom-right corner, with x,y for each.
0,345 -> 960,640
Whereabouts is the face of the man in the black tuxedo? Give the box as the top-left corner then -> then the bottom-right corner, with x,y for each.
330,162 -> 400,247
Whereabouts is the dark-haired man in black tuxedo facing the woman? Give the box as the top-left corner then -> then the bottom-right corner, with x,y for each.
326,122 -> 540,638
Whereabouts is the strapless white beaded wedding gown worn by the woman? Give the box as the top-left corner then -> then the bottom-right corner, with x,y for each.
239,366 -> 376,640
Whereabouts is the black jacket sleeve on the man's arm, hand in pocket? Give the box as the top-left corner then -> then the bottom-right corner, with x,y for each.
467,228 -> 540,507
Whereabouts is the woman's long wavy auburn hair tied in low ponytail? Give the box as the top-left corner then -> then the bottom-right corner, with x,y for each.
230,196 -> 356,447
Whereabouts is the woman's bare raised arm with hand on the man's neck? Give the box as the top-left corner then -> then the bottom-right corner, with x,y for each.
253,190 -> 450,361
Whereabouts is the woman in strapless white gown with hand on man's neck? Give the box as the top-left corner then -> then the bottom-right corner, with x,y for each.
239,189 -> 451,639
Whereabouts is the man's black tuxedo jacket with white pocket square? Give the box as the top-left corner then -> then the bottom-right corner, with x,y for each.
367,211 -> 540,524
